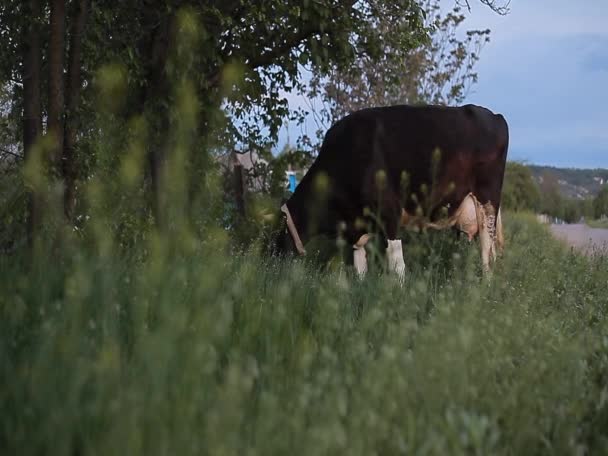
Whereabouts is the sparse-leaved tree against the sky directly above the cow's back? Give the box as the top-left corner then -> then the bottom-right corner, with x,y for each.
302,0 -> 490,143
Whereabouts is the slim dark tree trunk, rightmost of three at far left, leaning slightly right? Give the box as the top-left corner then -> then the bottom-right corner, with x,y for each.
61,0 -> 89,222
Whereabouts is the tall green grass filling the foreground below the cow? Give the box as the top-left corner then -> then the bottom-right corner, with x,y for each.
0,215 -> 608,455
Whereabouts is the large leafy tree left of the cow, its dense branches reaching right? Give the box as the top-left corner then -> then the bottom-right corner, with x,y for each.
59,0 -> 424,230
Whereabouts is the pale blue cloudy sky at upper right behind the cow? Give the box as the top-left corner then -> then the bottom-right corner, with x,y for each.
279,0 -> 608,168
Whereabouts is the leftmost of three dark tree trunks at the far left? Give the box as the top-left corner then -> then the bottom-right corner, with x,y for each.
22,0 -> 42,247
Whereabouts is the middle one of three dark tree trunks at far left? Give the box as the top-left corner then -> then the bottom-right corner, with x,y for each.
47,0 -> 65,169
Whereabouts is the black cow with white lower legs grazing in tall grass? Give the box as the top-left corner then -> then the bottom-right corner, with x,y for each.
274,105 -> 509,278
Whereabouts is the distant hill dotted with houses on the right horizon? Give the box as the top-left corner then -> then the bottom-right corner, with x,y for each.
528,165 -> 608,199
